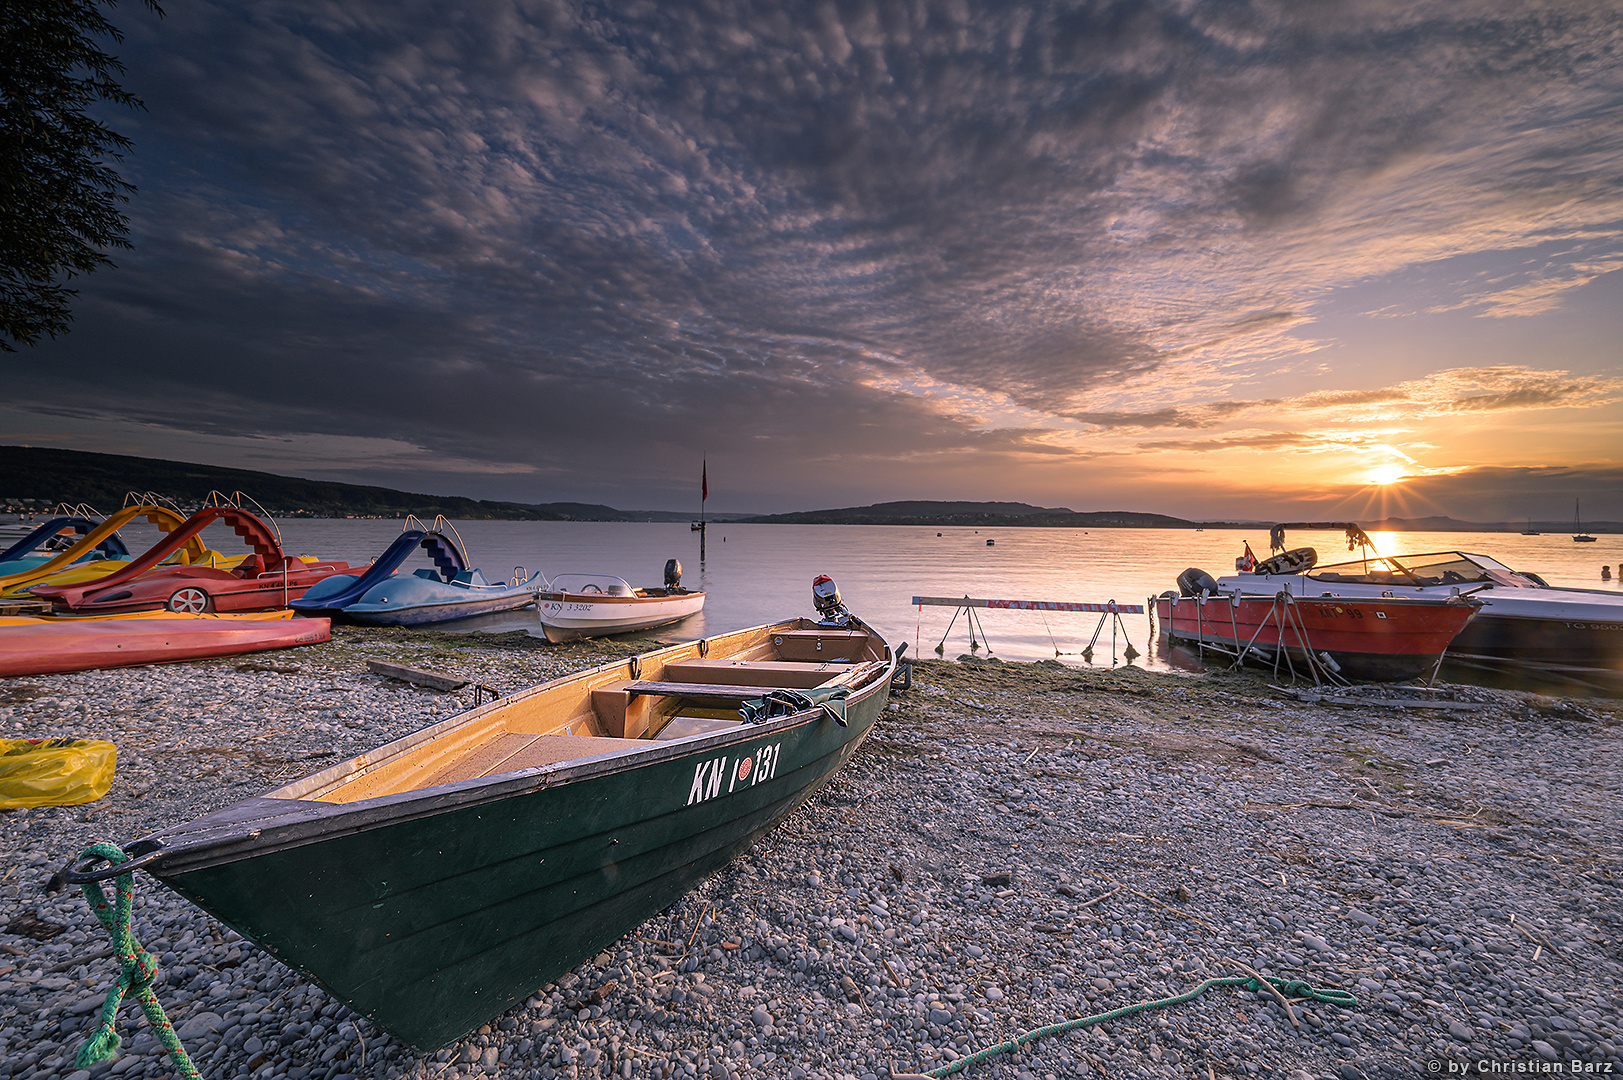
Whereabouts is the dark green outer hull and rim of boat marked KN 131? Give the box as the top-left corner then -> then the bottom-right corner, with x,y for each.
101,624 -> 896,1049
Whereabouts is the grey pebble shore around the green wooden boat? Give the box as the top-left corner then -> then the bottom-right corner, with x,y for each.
0,629 -> 1623,1080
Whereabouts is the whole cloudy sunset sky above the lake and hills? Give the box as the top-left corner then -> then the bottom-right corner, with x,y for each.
0,0 -> 1623,520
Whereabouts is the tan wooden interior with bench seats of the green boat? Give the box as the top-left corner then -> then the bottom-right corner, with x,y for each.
298,619 -> 891,802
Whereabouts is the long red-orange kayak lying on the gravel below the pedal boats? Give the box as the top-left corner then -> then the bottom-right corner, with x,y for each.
0,611 -> 333,677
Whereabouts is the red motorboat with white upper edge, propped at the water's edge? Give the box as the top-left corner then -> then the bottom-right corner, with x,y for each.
1154,570 -> 1480,682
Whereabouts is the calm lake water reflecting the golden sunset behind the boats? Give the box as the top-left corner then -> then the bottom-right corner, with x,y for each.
243,518 -> 1623,669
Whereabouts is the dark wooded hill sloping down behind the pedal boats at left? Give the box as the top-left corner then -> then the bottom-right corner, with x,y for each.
0,447 -> 645,521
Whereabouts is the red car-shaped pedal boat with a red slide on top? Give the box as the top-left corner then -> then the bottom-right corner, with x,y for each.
31,503 -> 365,614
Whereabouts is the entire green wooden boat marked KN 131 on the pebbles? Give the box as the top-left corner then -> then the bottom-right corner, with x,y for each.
63,580 -> 896,1049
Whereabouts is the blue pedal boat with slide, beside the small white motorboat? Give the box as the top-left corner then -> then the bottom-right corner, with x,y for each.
292,518 -> 545,627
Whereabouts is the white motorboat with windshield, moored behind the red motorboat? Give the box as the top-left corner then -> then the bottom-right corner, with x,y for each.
1217,521 -> 1623,680
